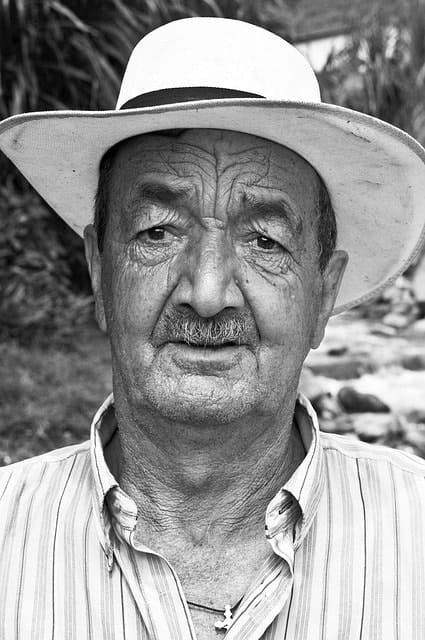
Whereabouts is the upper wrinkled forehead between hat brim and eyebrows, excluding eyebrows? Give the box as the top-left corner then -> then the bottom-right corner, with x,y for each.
110,129 -> 318,195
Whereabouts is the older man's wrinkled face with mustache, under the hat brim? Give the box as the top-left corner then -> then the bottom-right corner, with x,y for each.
86,130 -> 344,423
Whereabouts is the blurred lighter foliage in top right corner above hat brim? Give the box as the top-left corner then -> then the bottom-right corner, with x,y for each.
319,0 -> 425,144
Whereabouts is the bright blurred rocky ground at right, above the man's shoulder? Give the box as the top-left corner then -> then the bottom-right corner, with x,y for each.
301,311 -> 425,456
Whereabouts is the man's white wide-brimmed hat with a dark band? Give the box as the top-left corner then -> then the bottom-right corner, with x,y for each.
0,18 -> 425,313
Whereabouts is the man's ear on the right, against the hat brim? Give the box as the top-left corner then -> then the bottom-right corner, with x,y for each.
311,250 -> 348,349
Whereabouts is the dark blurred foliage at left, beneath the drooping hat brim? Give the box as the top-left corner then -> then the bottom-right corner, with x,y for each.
0,180 -> 92,344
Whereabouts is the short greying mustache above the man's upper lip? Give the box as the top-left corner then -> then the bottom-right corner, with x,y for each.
154,307 -> 258,347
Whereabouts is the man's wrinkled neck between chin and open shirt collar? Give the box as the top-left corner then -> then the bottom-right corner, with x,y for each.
107,397 -> 304,544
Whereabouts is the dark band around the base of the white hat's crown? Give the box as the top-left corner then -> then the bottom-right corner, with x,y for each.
120,87 -> 264,110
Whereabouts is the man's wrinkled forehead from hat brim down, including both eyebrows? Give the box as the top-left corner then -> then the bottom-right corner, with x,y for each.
105,129 -> 319,228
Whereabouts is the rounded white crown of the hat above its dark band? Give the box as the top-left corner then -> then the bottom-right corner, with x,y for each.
116,18 -> 320,109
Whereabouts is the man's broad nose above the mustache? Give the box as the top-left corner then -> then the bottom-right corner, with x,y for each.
172,228 -> 244,318
